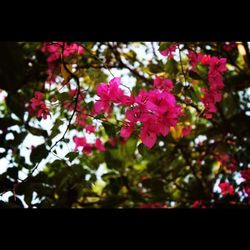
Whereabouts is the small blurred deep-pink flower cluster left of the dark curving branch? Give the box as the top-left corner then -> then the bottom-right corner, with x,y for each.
31,91 -> 50,119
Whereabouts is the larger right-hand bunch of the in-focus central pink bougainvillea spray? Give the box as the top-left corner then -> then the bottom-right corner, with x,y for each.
121,77 -> 181,148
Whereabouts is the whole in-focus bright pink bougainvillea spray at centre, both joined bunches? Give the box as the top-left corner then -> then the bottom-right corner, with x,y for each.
94,77 -> 181,148
